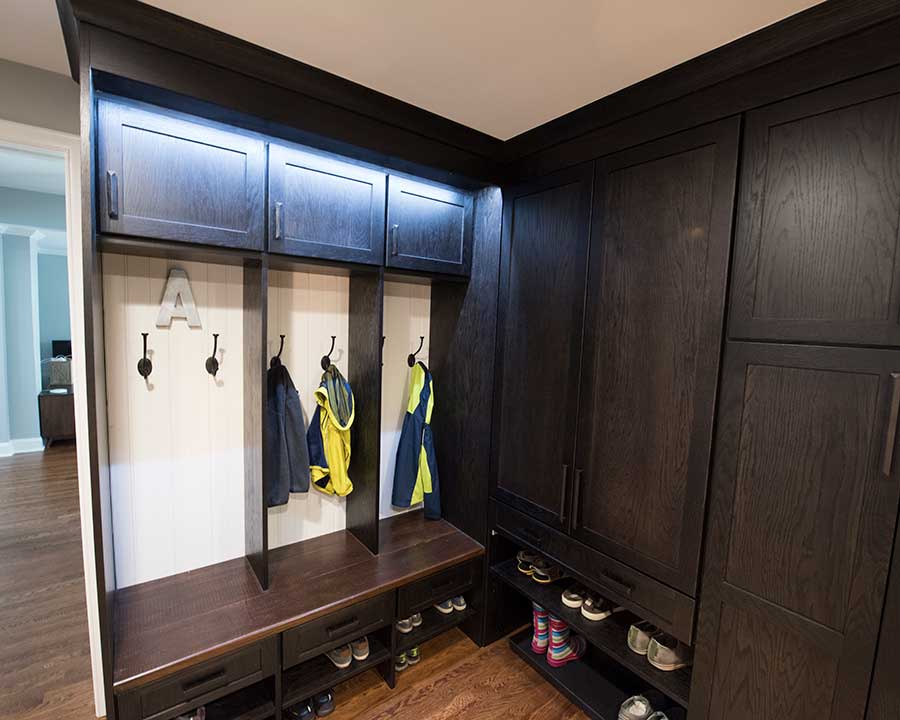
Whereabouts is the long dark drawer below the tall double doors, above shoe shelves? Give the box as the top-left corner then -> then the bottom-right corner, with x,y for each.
491,500 -> 694,643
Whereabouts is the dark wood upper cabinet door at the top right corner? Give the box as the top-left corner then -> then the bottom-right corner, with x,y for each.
729,70 -> 900,345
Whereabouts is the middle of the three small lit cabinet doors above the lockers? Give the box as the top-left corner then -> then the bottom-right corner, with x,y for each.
269,144 -> 386,265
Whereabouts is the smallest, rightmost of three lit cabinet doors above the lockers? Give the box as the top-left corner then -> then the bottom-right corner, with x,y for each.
386,175 -> 474,276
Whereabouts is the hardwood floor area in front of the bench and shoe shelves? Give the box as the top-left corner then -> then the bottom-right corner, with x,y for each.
329,629 -> 587,720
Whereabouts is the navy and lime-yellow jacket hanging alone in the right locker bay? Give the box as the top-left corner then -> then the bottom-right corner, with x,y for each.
391,363 -> 441,520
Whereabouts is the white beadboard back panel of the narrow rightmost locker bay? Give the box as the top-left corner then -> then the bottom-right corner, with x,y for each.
379,282 -> 432,518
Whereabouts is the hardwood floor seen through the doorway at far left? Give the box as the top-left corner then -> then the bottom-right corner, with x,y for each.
0,444 -> 94,720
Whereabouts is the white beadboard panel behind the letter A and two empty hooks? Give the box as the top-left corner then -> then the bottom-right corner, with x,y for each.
103,255 -> 244,587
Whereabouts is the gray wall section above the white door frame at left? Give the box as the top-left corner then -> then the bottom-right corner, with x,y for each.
0,60 -> 79,135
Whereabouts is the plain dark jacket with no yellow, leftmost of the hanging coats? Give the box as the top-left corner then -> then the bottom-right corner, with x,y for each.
264,363 -> 309,507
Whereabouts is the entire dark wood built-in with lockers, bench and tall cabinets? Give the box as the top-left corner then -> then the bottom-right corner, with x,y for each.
58,0 -> 900,720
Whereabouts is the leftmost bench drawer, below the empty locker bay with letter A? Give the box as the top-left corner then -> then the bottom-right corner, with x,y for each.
117,638 -> 278,720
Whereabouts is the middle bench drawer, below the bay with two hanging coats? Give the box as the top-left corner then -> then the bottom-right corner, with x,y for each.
282,592 -> 394,669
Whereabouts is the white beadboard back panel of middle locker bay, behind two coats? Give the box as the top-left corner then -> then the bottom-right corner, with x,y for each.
268,271 -> 355,548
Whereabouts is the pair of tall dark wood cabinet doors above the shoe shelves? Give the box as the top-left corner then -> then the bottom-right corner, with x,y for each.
494,118 -> 739,628
